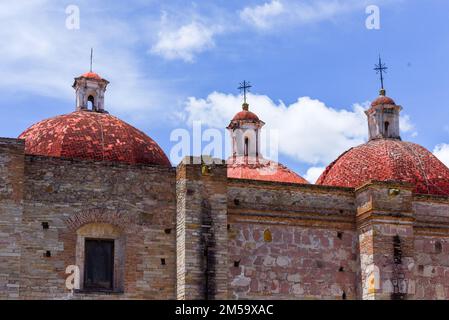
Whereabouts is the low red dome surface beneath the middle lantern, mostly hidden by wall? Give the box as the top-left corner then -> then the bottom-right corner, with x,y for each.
227,157 -> 309,184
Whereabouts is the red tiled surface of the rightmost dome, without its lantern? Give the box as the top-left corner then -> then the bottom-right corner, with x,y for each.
317,139 -> 449,196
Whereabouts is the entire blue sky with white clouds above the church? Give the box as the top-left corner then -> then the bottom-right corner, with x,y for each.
0,0 -> 449,179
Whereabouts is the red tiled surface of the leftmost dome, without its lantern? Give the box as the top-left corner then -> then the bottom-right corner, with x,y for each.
19,111 -> 170,166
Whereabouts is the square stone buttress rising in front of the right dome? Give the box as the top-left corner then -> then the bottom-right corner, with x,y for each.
356,181 -> 415,300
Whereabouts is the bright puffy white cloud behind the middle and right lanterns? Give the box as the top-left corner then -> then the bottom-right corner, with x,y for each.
186,92 -> 409,166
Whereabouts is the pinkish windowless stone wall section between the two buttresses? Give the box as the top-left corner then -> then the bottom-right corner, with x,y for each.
228,179 -> 360,299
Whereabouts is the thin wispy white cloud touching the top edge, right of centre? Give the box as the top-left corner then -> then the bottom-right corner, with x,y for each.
240,0 -> 368,29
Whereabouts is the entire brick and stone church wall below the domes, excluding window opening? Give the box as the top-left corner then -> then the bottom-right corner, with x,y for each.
0,138 -> 449,299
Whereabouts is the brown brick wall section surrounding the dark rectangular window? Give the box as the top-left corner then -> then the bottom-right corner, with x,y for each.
20,156 -> 176,299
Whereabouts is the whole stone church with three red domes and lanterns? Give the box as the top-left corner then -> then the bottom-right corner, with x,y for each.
0,67 -> 449,300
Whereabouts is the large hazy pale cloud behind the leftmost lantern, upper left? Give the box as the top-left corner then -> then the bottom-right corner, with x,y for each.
0,0 -> 175,116
